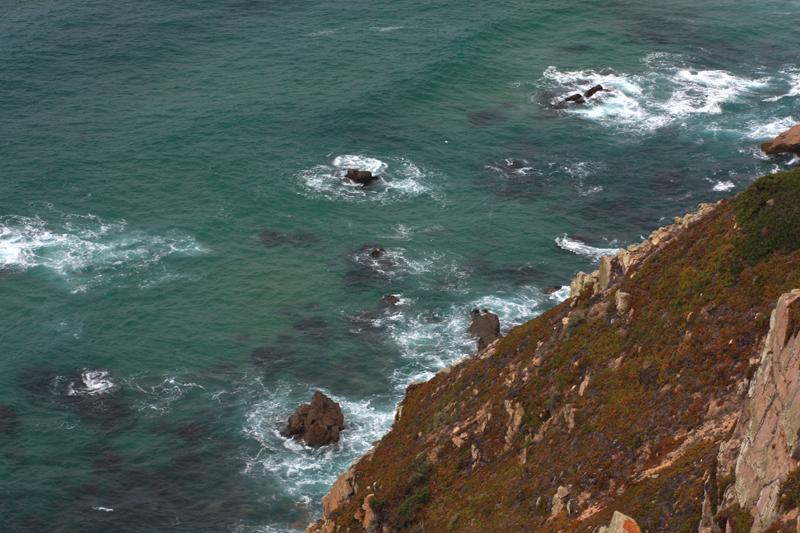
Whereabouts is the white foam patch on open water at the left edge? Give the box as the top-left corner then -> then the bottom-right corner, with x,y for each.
0,215 -> 206,292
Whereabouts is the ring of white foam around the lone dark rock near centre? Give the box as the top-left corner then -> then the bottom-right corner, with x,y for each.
299,155 -> 439,203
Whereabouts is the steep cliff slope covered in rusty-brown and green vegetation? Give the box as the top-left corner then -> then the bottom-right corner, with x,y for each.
309,171 -> 800,533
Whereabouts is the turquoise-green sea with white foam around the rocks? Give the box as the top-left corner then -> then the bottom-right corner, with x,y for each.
0,0 -> 800,531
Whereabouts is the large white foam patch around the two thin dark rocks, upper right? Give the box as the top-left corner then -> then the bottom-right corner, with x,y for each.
539,54 -> 770,133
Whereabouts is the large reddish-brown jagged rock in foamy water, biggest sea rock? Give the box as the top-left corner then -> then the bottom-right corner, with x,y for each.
283,391 -> 344,446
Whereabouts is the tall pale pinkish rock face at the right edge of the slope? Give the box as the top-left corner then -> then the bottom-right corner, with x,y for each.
734,289 -> 800,532
